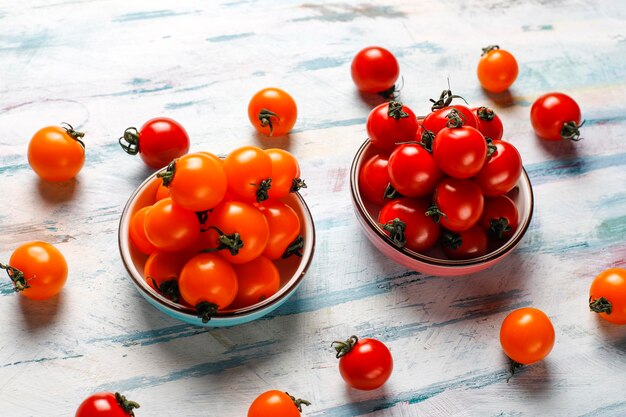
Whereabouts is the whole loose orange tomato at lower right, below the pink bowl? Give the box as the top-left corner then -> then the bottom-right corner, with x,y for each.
500,307 -> 554,365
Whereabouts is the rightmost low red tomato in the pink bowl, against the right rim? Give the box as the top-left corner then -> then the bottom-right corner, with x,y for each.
480,195 -> 519,239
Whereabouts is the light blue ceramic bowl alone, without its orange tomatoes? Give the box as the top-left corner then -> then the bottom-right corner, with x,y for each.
118,167 -> 315,327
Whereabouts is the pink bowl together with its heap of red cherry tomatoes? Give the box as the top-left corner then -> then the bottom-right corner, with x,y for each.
350,97 -> 533,276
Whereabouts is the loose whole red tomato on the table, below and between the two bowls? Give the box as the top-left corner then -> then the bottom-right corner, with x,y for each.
333,336 -> 393,391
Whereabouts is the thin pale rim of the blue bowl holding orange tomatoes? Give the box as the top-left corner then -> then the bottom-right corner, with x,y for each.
118,167 -> 315,320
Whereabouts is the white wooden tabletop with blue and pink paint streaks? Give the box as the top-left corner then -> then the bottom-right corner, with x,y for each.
0,0 -> 626,417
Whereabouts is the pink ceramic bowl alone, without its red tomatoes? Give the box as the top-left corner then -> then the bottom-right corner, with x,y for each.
350,139 -> 533,276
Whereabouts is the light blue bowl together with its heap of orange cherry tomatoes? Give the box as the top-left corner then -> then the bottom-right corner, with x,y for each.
119,146 -> 315,327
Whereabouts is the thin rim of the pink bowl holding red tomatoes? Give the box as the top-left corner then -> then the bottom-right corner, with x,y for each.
350,139 -> 535,269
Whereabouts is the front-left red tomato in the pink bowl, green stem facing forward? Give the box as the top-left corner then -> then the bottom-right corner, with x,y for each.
378,198 -> 440,252
